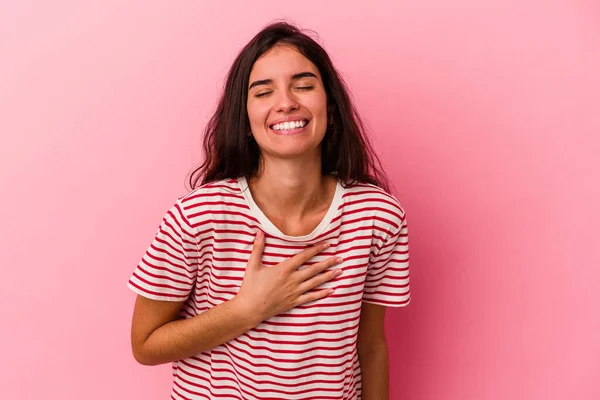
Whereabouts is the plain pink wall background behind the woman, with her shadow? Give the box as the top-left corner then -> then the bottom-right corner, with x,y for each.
0,0 -> 600,400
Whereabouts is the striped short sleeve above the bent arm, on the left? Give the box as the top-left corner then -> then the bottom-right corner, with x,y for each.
127,201 -> 198,301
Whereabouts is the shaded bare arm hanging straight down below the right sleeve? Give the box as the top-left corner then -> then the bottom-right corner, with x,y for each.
357,302 -> 389,400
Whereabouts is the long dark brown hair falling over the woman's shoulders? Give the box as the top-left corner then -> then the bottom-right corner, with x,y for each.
189,22 -> 389,191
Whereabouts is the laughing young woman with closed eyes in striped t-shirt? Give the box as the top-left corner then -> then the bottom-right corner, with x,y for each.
128,23 -> 410,400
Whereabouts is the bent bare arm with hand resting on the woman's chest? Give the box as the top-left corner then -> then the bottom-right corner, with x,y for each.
131,233 -> 341,365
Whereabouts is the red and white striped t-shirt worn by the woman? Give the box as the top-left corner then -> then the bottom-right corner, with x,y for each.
128,178 -> 410,400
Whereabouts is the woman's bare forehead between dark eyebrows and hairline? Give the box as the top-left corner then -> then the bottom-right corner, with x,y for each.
250,45 -> 321,81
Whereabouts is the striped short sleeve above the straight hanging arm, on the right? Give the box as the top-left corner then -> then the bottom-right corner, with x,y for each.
363,214 -> 410,307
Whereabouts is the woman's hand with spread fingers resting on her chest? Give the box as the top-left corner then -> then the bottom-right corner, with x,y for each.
236,230 -> 343,324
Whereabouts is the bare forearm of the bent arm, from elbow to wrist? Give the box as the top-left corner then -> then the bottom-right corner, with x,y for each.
136,298 -> 261,365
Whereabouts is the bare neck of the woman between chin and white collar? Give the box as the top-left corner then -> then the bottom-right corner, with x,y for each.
249,154 -> 334,219
